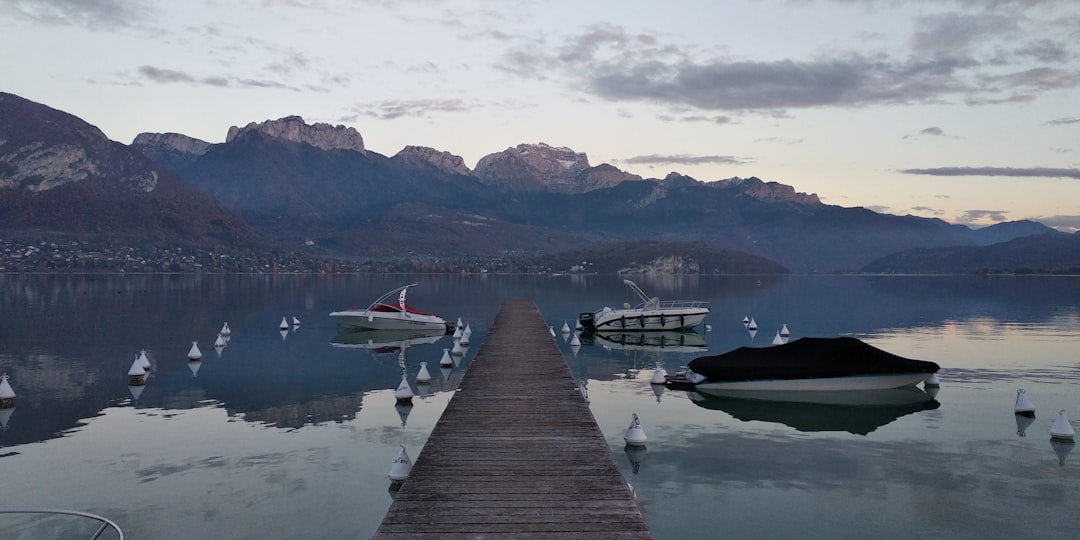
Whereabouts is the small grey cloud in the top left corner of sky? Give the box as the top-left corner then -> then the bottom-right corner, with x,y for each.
0,0 -> 157,30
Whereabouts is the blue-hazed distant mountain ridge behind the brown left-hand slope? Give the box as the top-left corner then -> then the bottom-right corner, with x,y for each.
133,117 -> 1052,272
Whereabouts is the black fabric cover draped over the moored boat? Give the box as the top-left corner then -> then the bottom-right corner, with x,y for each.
687,337 -> 939,381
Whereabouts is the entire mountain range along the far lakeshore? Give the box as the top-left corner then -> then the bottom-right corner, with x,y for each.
0,93 -> 1080,272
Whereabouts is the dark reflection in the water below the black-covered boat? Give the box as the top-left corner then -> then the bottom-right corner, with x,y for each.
687,387 -> 941,435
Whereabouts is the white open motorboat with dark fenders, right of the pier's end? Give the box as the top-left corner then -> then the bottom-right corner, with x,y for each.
578,280 -> 708,332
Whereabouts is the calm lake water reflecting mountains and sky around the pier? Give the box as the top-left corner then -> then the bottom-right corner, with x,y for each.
0,274 -> 1080,540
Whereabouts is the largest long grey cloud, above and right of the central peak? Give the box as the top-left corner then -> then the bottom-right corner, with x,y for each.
498,28 -> 977,112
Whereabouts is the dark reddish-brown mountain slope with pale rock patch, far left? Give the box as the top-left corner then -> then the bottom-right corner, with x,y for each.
0,93 -> 260,248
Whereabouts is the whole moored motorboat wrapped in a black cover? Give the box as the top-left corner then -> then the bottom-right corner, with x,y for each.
686,337 -> 939,395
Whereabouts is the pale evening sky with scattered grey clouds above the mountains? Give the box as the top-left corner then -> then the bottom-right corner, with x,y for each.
0,0 -> 1080,231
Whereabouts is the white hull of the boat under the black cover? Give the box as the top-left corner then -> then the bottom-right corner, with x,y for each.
694,373 -> 930,396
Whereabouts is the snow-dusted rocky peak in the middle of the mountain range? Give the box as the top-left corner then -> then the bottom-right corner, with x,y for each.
473,143 -> 640,193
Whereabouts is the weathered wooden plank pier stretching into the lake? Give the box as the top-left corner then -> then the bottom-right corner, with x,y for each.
375,300 -> 652,540
